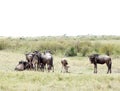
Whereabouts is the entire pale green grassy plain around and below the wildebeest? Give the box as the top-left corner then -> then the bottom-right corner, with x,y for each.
0,51 -> 120,91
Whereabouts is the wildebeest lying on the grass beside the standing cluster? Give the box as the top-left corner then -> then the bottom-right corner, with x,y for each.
15,60 -> 30,71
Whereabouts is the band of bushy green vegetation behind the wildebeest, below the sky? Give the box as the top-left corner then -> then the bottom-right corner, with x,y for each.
0,35 -> 120,56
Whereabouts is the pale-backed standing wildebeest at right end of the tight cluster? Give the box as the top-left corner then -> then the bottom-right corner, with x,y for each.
41,51 -> 54,72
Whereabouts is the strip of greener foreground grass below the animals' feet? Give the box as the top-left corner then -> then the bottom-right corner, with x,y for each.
0,71 -> 120,91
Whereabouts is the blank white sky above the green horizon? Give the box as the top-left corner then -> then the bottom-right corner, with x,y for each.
0,0 -> 120,37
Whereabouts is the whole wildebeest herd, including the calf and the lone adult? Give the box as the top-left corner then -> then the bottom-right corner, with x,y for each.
15,50 -> 112,73
